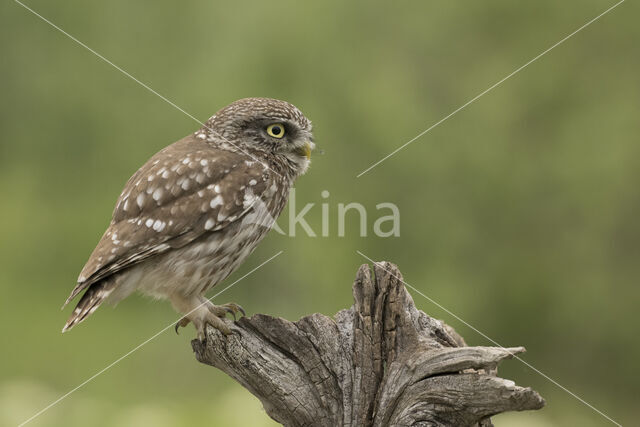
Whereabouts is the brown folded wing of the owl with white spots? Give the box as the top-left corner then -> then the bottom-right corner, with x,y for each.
65,136 -> 276,305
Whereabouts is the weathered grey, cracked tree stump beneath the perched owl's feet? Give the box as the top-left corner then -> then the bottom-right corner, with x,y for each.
192,262 -> 544,427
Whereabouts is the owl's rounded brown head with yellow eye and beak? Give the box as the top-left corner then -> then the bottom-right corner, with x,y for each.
203,98 -> 315,174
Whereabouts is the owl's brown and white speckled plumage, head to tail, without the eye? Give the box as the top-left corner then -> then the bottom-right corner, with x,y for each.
63,98 -> 313,335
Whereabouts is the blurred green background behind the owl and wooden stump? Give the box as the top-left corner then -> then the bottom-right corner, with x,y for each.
0,0 -> 640,427
